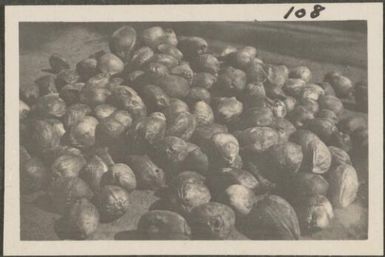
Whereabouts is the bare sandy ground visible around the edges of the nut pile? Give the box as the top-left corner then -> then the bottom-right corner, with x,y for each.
20,23 -> 368,240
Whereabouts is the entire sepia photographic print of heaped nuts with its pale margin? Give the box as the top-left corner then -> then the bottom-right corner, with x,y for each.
4,4 -> 383,254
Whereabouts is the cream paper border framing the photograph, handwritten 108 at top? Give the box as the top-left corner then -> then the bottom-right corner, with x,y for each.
3,3 -> 384,255
